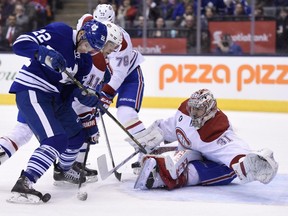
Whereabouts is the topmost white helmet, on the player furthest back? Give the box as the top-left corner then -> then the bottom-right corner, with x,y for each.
93,4 -> 115,23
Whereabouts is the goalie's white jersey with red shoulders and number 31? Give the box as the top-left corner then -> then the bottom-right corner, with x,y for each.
158,99 -> 251,167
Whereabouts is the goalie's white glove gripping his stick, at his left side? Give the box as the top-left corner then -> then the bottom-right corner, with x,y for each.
125,121 -> 164,154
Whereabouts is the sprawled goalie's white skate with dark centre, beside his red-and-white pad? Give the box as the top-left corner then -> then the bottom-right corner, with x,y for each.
134,158 -> 165,190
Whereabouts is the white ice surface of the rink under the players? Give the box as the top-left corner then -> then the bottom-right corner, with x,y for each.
0,106 -> 288,216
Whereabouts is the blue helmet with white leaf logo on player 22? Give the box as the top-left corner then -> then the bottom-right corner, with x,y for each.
81,20 -> 107,50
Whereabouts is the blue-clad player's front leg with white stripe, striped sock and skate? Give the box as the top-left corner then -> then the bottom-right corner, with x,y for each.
11,90 -> 71,199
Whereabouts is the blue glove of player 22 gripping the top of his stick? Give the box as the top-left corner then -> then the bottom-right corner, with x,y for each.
36,45 -> 66,72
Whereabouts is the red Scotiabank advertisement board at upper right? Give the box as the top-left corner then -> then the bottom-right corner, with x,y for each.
209,20 -> 276,54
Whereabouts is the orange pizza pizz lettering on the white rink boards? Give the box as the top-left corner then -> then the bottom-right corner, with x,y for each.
159,64 -> 288,92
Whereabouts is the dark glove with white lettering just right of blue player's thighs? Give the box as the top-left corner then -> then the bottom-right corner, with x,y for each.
79,110 -> 100,145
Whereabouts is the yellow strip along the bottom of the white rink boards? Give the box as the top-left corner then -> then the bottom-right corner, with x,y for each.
0,94 -> 288,113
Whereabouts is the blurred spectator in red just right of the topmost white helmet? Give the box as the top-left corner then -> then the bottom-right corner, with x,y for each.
117,0 -> 137,28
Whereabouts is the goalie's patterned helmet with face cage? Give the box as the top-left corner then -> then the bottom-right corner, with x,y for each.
186,89 -> 217,129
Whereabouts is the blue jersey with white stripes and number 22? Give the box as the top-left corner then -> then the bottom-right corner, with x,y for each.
9,22 -> 92,94
